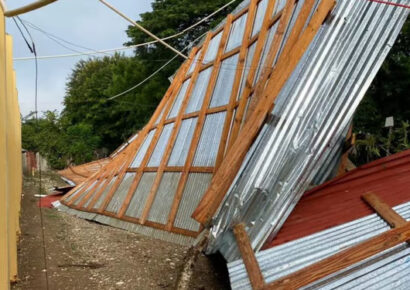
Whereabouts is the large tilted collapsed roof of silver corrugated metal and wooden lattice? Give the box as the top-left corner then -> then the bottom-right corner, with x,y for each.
61,0 -> 408,278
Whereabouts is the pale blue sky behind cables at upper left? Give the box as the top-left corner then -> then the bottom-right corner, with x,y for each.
6,0 -> 153,116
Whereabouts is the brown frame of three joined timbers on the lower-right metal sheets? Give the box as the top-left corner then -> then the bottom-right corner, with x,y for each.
233,193 -> 410,290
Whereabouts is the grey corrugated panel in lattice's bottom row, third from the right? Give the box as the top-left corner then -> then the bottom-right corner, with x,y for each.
125,172 -> 157,218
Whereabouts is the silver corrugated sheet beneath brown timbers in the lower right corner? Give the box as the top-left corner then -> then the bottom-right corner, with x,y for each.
228,202 -> 410,289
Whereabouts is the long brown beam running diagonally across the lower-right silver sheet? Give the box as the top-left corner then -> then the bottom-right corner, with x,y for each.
264,223 -> 410,289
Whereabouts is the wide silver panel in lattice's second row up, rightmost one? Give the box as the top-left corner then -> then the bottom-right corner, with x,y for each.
193,112 -> 226,166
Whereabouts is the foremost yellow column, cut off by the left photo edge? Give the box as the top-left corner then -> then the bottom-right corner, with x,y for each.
0,5 -> 10,290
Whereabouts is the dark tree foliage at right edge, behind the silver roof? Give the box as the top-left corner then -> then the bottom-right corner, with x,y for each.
352,20 -> 410,165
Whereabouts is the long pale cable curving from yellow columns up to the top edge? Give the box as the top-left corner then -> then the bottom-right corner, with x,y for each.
14,0 -> 238,61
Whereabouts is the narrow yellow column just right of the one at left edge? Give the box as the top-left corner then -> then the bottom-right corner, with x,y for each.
6,35 -> 20,282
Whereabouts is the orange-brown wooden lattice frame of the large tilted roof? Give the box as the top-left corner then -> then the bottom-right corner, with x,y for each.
62,0 -> 335,237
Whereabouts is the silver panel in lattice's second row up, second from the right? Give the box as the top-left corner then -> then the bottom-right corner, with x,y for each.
168,118 -> 198,166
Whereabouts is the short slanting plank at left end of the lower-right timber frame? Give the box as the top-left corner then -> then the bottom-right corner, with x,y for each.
233,223 -> 265,290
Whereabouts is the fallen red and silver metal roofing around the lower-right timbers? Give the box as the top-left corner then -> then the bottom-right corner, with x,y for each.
228,150 -> 410,289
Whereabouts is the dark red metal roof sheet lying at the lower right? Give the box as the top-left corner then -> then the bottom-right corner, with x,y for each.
264,150 -> 410,248
